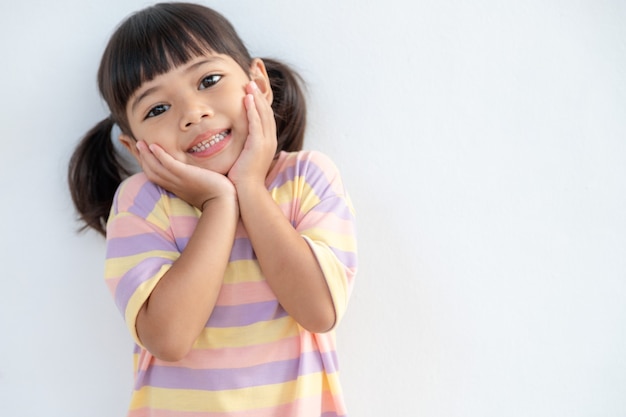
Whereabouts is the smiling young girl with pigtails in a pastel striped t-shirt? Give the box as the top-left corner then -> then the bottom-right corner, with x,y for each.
69,3 -> 356,417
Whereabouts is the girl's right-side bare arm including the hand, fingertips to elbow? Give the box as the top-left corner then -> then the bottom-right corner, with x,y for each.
229,82 -> 336,332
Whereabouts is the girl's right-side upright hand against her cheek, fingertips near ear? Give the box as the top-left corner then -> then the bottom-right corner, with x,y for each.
228,81 -> 277,187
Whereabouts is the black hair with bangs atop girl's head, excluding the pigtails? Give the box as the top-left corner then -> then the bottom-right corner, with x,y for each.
98,3 -> 251,119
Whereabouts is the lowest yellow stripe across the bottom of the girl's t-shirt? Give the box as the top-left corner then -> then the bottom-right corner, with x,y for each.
130,372 -> 337,413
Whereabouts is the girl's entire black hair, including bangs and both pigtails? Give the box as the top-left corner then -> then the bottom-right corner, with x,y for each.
68,3 -> 306,235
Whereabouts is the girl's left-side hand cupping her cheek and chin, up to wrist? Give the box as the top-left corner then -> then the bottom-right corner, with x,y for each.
137,141 -> 236,210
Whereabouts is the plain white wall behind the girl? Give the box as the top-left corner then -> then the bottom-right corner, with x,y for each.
0,0 -> 626,417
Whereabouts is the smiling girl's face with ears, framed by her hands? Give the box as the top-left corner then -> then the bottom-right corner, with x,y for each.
120,53 -> 272,174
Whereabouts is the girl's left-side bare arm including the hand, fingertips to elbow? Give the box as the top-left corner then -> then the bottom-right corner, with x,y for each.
136,144 -> 239,361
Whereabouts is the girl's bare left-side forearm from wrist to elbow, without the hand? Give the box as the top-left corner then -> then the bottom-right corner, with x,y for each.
136,196 -> 239,360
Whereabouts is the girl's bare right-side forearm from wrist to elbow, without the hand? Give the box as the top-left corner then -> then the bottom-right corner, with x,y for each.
237,185 -> 335,332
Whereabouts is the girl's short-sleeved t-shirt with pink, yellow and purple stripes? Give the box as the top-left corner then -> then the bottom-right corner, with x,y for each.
105,151 -> 357,417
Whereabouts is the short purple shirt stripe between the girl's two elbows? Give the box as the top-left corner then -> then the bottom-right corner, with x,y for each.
206,300 -> 287,327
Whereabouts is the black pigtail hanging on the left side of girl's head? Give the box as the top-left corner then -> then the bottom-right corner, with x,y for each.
68,117 -> 130,235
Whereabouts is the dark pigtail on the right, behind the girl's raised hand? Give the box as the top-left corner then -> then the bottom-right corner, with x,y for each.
263,58 -> 307,152
